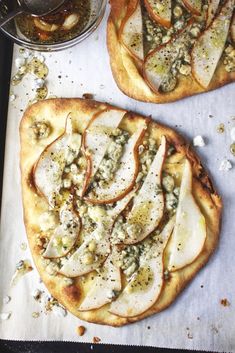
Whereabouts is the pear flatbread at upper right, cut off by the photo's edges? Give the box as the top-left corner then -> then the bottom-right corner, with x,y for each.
107,0 -> 235,103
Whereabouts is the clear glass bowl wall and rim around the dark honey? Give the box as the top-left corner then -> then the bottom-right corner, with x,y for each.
0,0 -> 107,51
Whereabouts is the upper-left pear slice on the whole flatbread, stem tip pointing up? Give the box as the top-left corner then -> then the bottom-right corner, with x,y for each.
34,115 -> 81,208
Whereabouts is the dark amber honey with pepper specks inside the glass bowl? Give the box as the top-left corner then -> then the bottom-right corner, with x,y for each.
16,0 -> 91,44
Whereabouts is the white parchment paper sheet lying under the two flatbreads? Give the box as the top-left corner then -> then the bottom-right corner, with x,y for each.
0,6 -> 235,352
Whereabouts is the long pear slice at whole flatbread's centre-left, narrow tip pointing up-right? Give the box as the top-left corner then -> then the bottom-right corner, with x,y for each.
60,188 -> 136,277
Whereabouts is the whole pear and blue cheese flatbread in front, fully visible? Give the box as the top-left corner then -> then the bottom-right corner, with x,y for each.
20,99 -> 222,326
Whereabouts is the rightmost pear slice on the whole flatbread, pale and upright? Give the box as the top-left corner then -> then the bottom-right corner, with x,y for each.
168,160 -> 206,271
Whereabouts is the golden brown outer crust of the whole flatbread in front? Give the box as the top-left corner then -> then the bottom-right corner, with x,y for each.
20,99 -> 222,326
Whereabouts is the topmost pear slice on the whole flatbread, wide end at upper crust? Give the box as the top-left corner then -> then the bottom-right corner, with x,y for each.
83,109 -> 126,195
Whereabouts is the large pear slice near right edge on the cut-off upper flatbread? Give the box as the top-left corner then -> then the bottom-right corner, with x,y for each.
191,0 -> 234,88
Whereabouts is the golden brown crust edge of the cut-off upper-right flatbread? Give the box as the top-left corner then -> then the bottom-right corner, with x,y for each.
107,0 -> 235,103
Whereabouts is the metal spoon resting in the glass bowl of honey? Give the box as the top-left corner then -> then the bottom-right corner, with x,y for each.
0,0 -> 65,27
